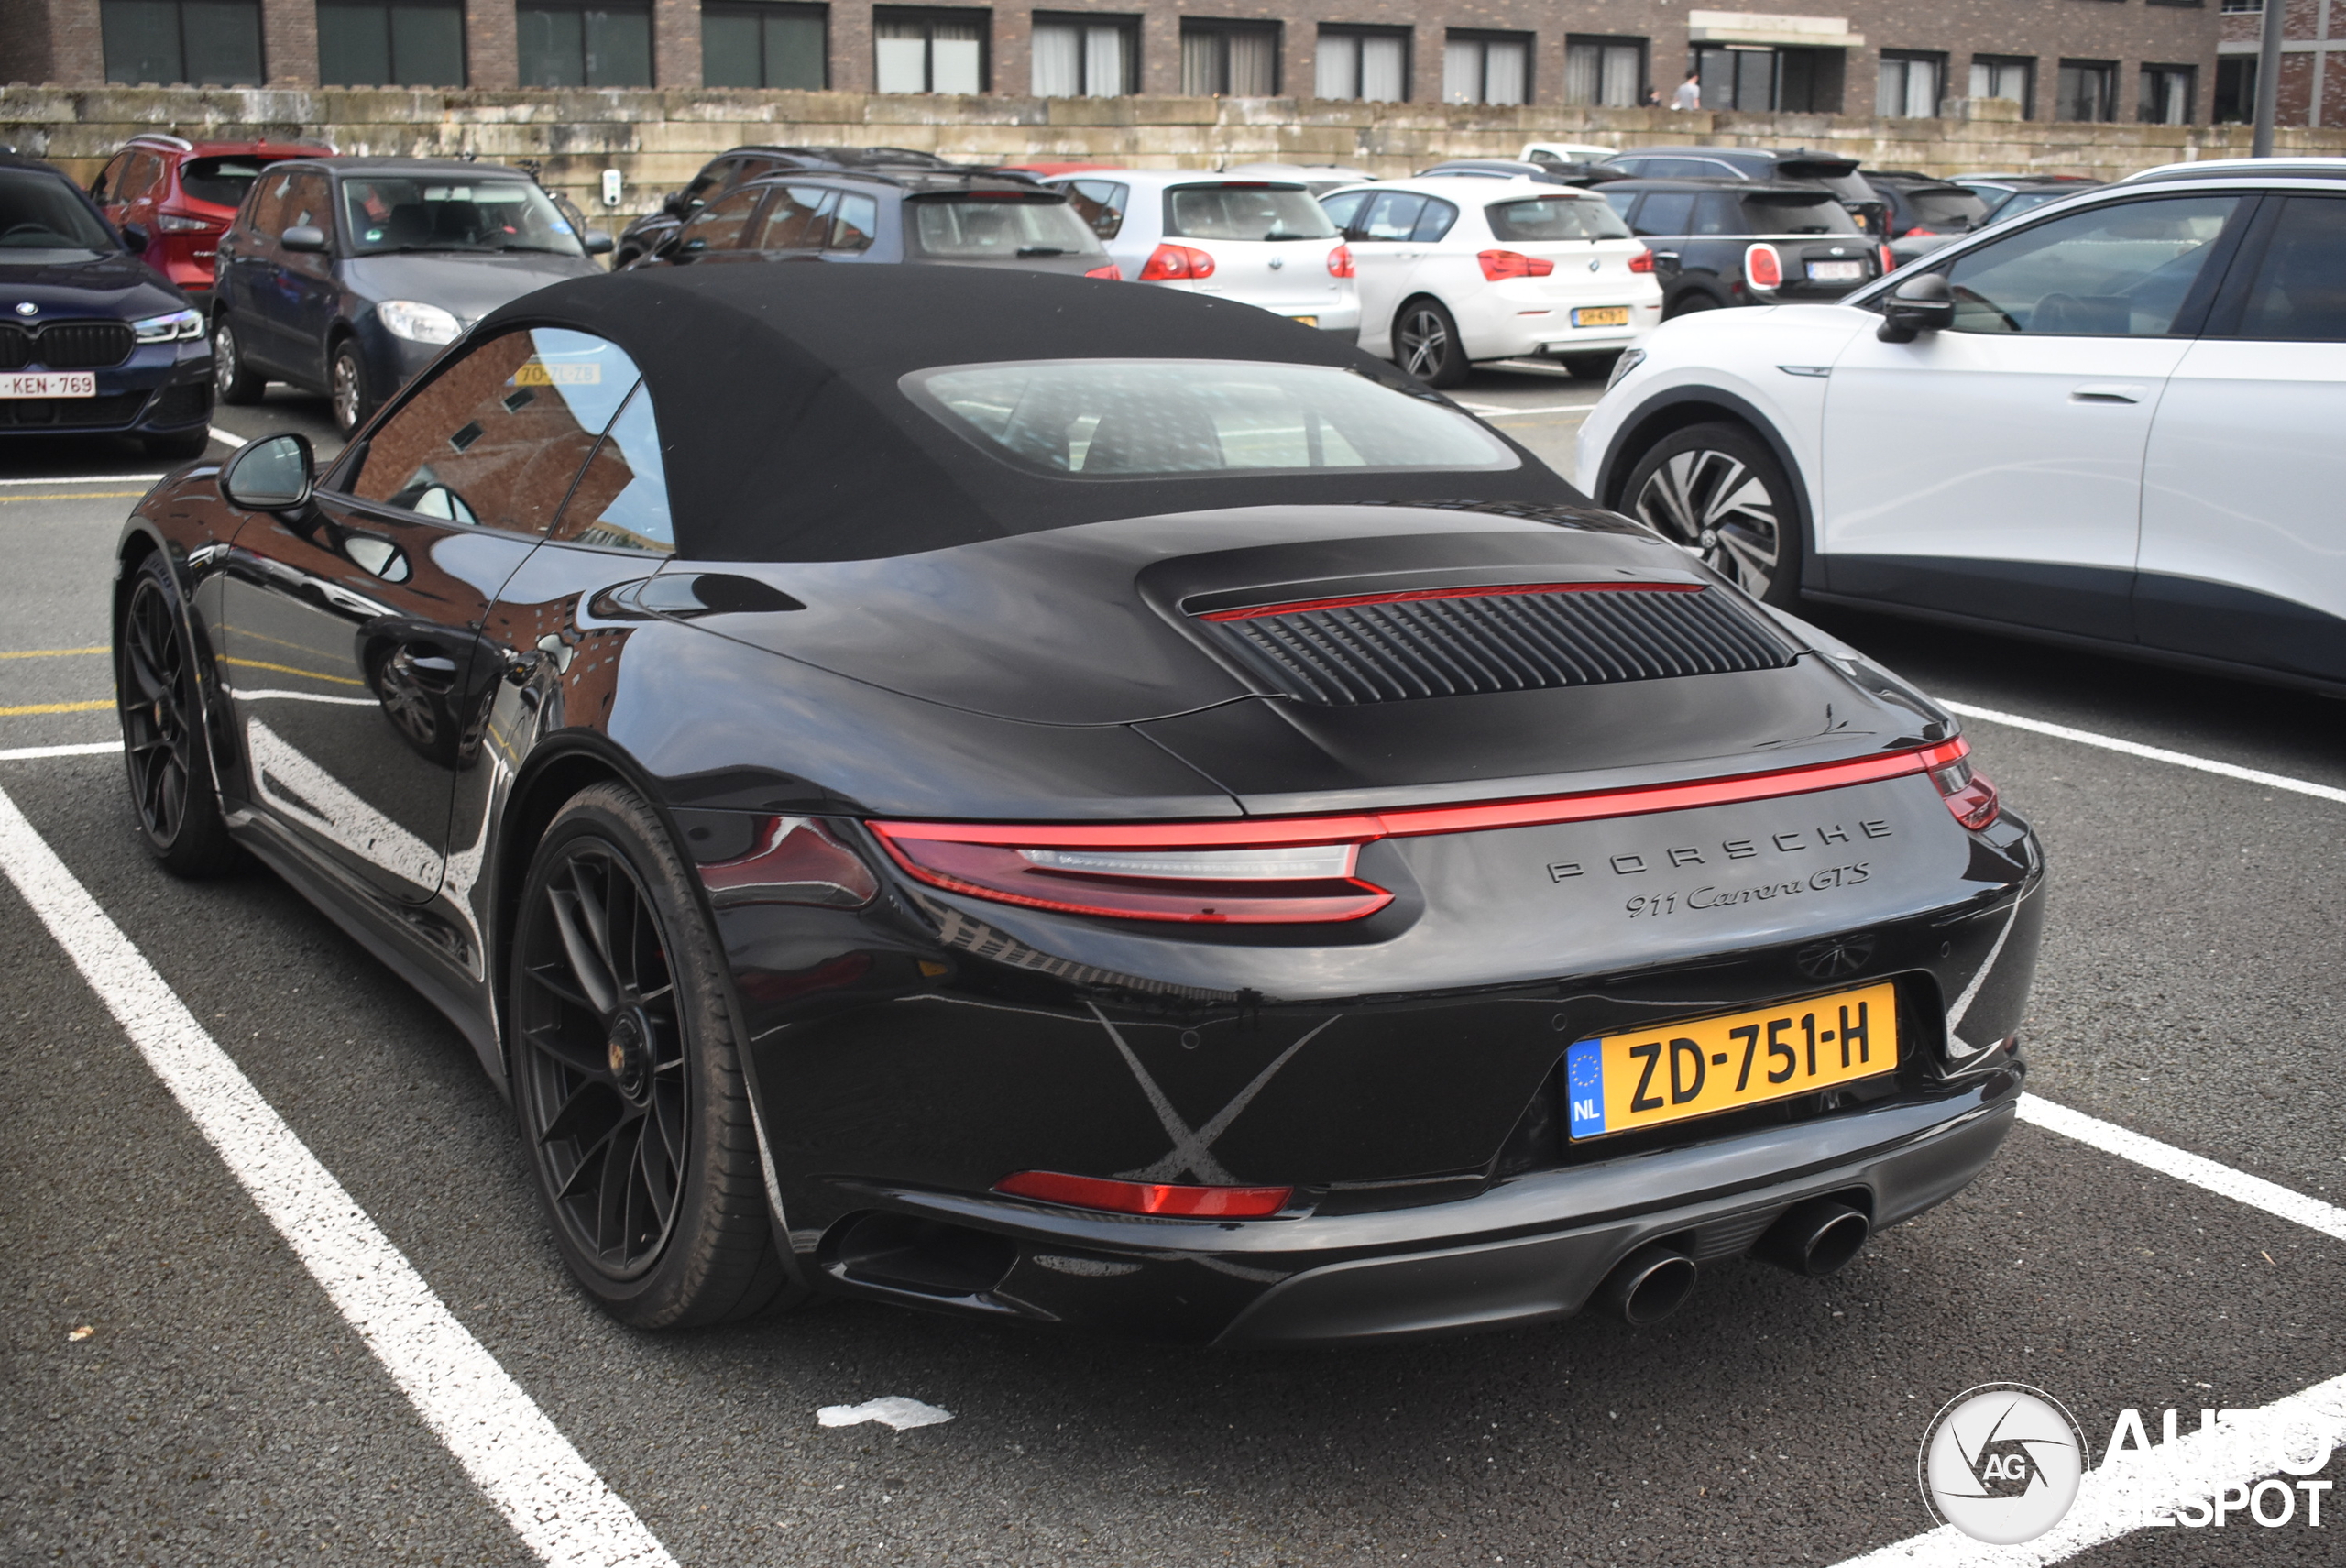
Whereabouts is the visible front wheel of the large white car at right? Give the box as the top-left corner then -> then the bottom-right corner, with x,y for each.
1624,425 -> 1800,610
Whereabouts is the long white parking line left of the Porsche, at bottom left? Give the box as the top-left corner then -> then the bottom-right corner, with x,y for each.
0,791 -> 675,1568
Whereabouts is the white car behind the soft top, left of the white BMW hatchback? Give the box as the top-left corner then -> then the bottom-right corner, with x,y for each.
1044,169 -> 1361,340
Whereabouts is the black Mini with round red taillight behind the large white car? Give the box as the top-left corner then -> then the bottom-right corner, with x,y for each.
1597,179 -> 1881,319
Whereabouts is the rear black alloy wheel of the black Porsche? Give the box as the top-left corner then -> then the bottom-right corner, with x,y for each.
511,784 -> 805,1329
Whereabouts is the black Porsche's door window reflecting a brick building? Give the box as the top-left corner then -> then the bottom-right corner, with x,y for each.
352,326 -> 666,532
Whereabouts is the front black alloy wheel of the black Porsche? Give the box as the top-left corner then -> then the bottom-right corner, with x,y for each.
115,556 -> 237,875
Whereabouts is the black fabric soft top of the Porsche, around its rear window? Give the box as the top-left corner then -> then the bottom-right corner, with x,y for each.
474,263 -> 1586,561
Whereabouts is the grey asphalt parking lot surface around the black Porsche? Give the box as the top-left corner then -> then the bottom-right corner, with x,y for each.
0,371 -> 2346,1568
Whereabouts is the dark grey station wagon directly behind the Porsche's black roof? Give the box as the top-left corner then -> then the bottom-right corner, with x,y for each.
631,169 -> 1117,277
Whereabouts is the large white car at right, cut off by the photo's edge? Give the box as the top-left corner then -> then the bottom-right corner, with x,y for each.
1579,159 -> 2346,695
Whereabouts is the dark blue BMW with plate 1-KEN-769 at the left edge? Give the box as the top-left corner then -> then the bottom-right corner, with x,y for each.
0,155 -> 211,460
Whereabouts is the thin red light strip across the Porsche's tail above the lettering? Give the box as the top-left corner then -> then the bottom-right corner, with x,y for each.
871,740 -> 1970,850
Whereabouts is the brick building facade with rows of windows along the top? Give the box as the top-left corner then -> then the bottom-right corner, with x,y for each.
0,0 -> 2223,125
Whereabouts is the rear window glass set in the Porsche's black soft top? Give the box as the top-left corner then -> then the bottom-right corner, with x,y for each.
904,359 -> 1518,479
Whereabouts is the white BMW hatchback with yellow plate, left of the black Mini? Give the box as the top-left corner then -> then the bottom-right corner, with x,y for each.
1321,174 -> 1661,388
